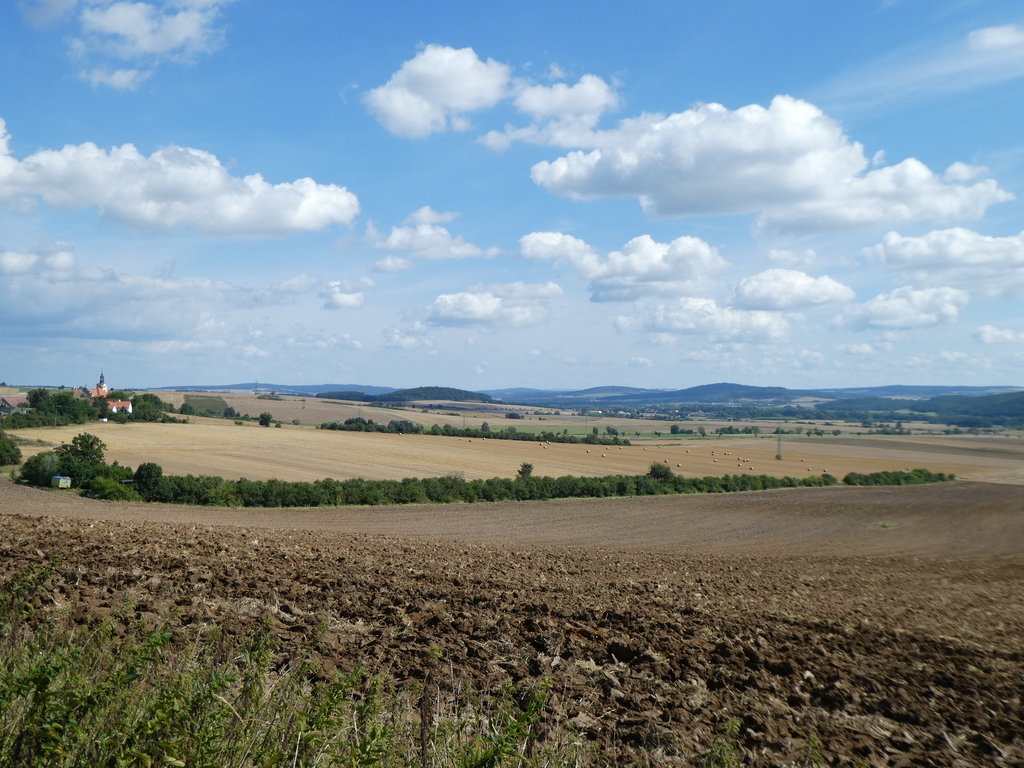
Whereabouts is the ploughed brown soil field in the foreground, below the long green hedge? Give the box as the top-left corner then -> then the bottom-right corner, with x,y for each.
0,480 -> 1024,766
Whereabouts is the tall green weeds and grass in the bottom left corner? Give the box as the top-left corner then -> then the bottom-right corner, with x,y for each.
0,563 -> 590,768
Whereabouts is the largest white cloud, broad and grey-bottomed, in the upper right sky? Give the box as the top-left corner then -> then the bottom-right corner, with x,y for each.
530,96 -> 1013,230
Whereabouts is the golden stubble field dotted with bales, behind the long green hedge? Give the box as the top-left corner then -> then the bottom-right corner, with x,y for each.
14,418 -> 1024,484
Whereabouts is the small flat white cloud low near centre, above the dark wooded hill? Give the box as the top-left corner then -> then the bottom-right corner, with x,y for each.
429,283 -> 562,326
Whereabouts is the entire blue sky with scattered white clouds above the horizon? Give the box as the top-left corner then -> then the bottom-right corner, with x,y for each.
0,0 -> 1024,389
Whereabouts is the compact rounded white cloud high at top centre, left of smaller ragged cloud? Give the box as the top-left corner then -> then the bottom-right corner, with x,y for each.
364,45 -> 510,138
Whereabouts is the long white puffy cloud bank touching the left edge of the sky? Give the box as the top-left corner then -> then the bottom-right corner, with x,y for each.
0,119 -> 359,237
